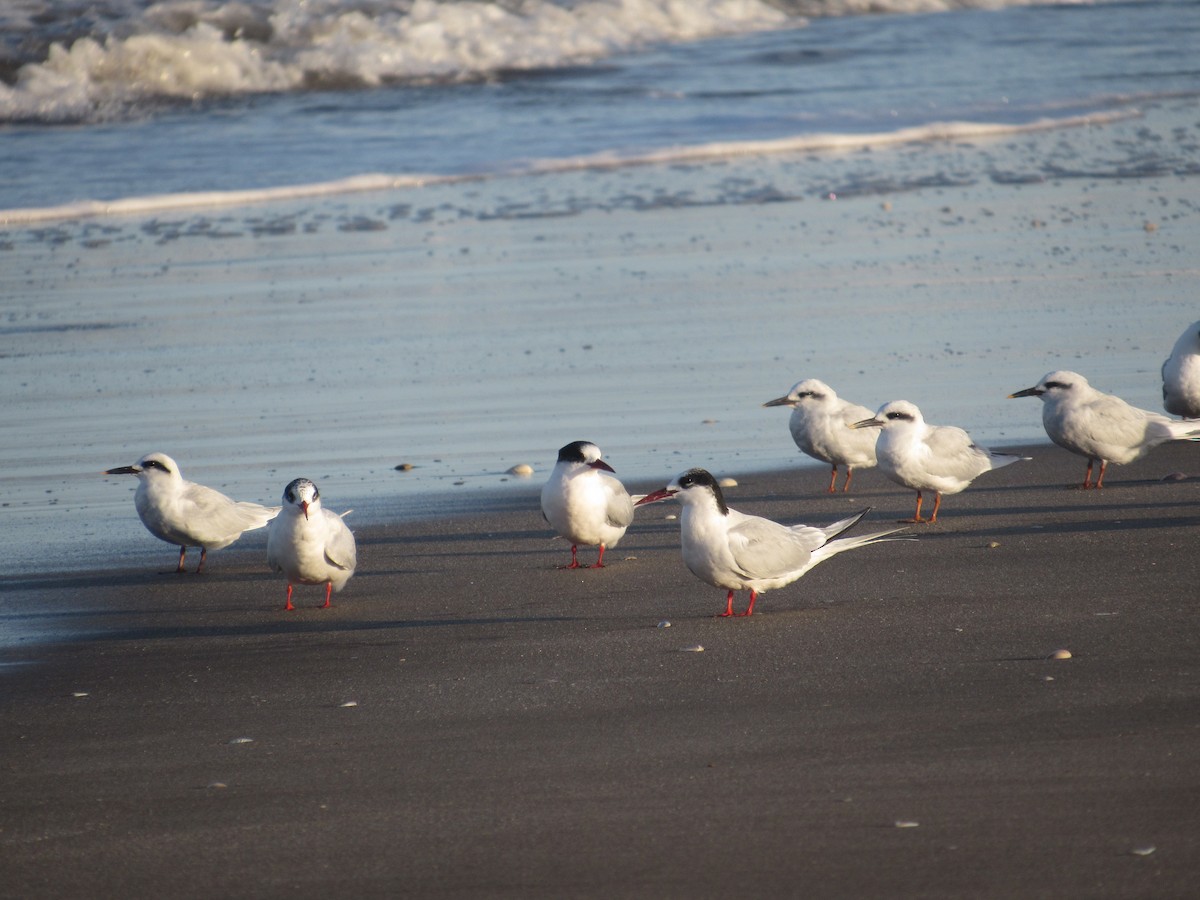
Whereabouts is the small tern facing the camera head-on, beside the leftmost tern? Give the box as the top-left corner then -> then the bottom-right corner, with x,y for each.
266,478 -> 359,610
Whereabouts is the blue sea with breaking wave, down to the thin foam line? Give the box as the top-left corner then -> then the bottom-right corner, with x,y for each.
0,0 -> 1200,213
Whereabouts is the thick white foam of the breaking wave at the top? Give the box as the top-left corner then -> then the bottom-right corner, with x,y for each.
0,0 -> 1084,124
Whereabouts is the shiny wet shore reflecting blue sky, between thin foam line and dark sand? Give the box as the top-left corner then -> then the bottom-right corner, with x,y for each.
0,156 -> 1200,575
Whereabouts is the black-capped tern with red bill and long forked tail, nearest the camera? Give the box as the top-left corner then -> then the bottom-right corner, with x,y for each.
637,469 -> 902,617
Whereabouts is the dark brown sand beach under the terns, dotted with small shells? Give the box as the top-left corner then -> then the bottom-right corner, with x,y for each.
0,444 -> 1200,898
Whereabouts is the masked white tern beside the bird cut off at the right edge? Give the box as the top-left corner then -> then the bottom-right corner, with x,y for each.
1008,372 -> 1200,490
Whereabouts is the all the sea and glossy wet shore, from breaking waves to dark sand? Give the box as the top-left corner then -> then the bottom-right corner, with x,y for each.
0,0 -> 1200,587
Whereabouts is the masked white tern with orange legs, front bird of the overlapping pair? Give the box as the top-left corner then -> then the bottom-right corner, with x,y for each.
852,400 -> 1030,524
